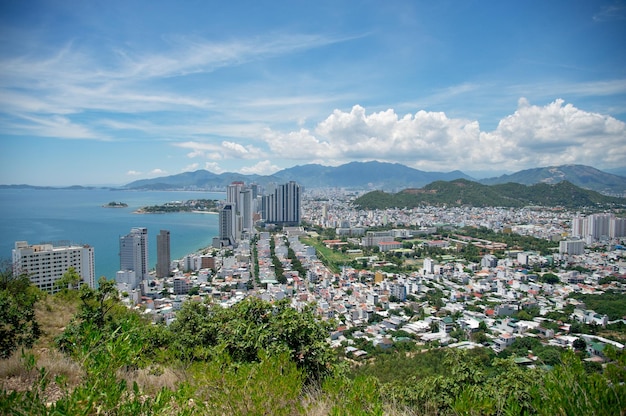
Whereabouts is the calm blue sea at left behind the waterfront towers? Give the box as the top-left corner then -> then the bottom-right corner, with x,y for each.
0,188 -> 226,279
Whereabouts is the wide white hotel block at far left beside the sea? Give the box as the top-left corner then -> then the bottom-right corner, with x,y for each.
12,241 -> 96,293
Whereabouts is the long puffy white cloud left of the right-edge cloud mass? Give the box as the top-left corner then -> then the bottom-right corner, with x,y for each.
264,105 -> 479,164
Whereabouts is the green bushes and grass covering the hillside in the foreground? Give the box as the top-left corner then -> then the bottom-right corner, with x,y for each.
0,272 -> 626,415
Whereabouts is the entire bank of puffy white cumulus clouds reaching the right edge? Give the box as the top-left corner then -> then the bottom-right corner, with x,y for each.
263,98 -> 626,170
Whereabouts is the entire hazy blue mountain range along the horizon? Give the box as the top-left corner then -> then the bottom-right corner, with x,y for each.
124,161 -> 626,196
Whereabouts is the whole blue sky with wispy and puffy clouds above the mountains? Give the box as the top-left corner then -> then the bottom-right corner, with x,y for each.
0,0 -> 626,186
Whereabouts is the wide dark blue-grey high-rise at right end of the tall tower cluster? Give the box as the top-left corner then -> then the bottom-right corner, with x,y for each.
263,181 -> 300,225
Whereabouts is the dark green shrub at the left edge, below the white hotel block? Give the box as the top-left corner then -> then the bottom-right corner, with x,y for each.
0,266 -> 41,358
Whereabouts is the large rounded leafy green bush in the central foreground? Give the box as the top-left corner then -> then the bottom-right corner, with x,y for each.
170,298 -> 335,379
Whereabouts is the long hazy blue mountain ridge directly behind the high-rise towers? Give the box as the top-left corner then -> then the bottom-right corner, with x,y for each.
124,162 -> 471,190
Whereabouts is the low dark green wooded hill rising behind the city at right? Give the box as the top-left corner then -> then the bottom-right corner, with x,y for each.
354,179 -> 626,209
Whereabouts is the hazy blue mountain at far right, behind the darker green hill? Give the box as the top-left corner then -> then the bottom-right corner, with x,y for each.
480,165 -> 626,196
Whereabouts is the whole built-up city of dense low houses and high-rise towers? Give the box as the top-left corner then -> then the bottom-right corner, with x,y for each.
13,182 -> 626,364
